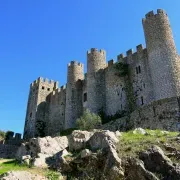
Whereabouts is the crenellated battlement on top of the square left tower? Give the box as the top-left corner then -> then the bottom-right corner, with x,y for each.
30,77 -> 59,88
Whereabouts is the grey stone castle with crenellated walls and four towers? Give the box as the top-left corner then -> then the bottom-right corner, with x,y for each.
24,9 -> 180,139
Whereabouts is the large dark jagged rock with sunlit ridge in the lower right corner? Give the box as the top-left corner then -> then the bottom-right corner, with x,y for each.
139,145 -> 180,180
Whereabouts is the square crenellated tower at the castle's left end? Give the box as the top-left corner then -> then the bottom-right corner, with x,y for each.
23,77 -> 58,139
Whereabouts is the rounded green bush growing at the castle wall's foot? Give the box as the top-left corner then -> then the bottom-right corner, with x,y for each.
76,110 -> 101,130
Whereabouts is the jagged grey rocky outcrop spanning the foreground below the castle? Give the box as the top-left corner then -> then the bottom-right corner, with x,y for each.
14,128 -> 180,180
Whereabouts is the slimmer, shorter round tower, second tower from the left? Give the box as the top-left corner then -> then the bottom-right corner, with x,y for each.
65,61 -> 84,129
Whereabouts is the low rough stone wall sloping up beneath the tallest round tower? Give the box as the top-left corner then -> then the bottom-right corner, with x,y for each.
102,97 -> 180,131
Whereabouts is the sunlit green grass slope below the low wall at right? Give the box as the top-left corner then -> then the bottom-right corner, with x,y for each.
117,129 -> 180,157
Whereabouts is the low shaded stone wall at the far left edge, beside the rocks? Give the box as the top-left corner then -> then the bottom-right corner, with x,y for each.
0,144 -> 19,158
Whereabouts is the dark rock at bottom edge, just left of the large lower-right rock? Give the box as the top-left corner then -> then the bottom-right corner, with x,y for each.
125,158 -> 159,180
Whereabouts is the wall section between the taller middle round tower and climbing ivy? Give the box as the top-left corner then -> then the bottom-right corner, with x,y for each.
105,60 -> 127,115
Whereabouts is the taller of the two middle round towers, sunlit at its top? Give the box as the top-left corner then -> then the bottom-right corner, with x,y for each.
87,48 -> 106,113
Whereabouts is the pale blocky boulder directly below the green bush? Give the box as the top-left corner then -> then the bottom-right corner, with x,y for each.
68,130 -> 94,151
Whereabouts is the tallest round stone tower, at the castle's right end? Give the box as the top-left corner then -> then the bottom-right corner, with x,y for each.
143,9 -> 180,100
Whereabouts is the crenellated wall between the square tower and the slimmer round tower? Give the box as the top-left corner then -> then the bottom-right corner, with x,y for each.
47,86 -> 66,136
